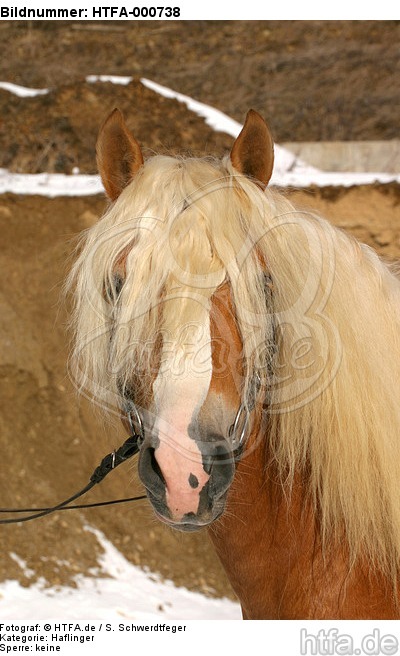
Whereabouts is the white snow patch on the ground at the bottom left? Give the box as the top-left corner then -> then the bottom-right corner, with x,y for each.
0,526 -> 241,621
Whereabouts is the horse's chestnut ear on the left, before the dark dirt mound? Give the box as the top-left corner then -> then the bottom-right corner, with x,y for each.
96,109 -> 143,200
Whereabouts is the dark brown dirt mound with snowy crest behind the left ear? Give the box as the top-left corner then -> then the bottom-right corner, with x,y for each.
0,80 -> 232,173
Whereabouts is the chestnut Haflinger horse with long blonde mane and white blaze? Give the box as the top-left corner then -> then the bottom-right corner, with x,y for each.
69,110 -> 400,619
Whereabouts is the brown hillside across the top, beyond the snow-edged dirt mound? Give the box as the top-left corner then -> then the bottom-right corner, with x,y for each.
0,21 -> 400,143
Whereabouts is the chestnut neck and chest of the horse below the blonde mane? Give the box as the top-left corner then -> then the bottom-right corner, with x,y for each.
209,416 -> 399,619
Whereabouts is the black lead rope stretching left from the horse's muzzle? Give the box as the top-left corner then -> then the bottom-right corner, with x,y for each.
0,433 -> 146,524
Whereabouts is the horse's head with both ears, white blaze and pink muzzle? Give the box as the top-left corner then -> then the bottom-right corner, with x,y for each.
91,110 -> 273,531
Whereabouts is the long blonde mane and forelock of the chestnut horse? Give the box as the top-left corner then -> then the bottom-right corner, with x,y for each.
68,156 -> 400,576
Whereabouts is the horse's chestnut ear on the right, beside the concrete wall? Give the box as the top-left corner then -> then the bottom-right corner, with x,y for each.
231,109 -> 274,186
